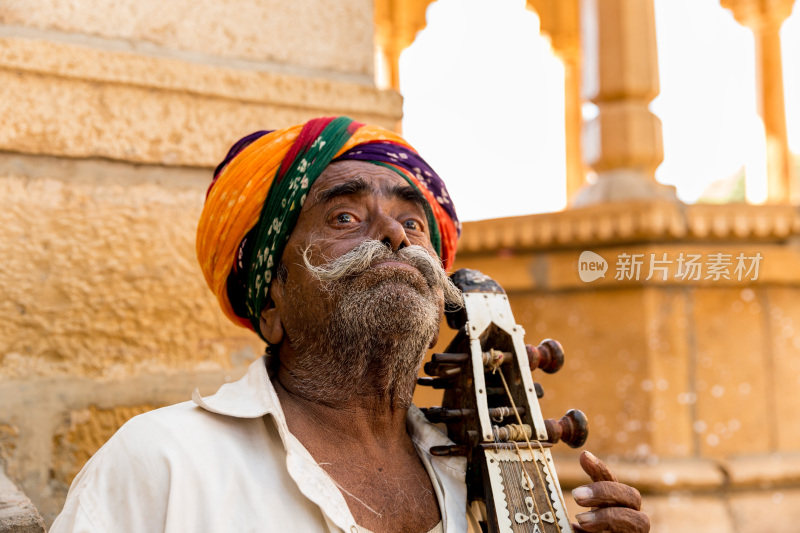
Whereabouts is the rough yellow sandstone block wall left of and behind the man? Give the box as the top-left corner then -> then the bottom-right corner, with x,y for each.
0,0 -> 401,523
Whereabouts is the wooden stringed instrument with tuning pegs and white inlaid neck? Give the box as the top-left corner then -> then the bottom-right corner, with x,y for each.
418,269 -> 588,533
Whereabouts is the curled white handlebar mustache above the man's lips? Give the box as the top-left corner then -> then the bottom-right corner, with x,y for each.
303,239 -> 463,309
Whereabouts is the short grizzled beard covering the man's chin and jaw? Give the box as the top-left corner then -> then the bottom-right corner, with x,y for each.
285,267 -> 440,408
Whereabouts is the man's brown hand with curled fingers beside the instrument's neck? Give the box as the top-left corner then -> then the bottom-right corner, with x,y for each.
572,451 -> 650,533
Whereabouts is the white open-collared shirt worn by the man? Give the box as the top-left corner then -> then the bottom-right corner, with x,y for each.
50,358 -> 467,533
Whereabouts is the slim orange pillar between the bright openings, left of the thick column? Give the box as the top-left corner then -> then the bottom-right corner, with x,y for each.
527,0 -> 586,202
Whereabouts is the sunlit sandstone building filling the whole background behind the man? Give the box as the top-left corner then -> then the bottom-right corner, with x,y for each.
0,0 -> 800,533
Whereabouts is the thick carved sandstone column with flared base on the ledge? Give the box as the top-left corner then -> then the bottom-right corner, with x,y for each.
573,0 -> 675,206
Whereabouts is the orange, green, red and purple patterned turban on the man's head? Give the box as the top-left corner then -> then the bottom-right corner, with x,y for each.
196,117 -> 461,335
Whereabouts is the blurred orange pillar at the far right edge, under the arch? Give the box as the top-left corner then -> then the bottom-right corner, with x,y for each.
720,0 -> 800,203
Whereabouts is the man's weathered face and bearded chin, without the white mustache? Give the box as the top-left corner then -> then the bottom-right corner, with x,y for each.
271,161 -> 443,405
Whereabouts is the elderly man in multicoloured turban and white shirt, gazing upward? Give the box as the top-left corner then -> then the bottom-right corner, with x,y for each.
52,117 -> 649,533
